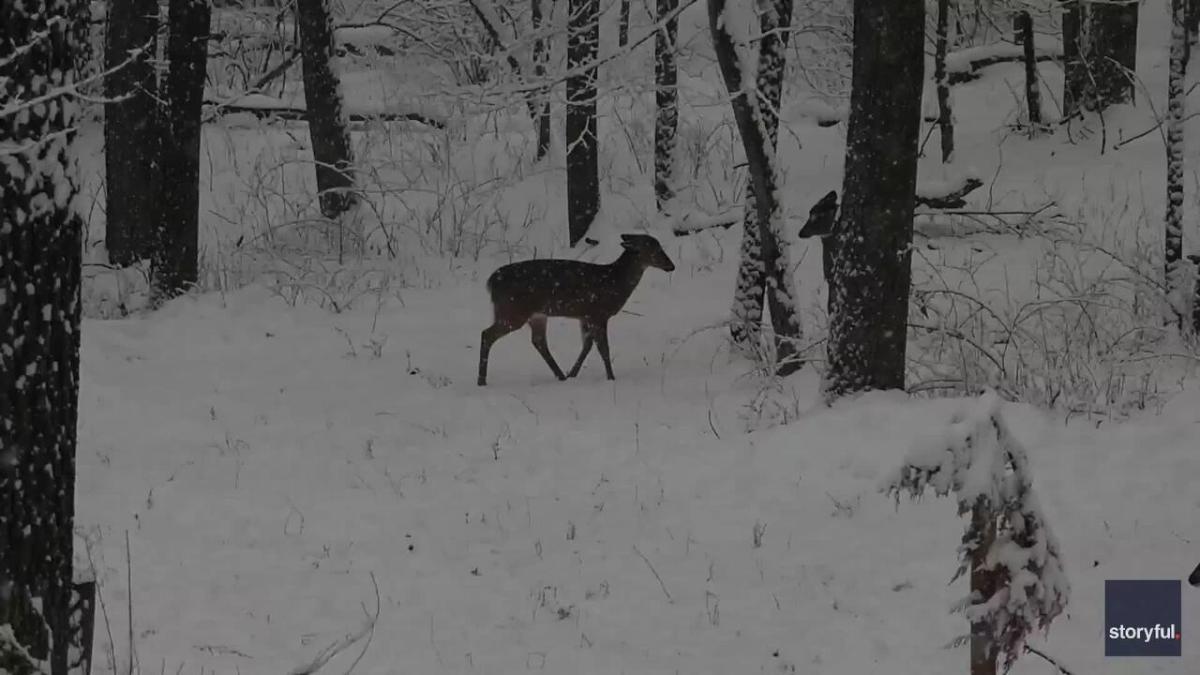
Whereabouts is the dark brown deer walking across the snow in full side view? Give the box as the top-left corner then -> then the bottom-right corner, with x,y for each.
479,234 -> 674,387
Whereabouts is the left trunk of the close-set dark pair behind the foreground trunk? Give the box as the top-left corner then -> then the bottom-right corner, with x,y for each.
104,0 -> 160,267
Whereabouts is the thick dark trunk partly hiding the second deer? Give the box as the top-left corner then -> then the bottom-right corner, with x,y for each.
824,0 -> 925,399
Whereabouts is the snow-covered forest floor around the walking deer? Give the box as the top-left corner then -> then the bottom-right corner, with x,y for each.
77,1 -> 1200,675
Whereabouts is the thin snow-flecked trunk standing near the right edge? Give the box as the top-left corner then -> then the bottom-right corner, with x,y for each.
1163,0 -> 1193,328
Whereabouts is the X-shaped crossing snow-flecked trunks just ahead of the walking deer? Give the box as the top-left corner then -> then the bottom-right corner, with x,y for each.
708,0 -> 800,376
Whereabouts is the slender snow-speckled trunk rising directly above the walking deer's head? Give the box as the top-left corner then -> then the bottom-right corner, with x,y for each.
654,0 -> 679,213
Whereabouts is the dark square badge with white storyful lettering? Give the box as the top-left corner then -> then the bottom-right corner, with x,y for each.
1104,579 -> 1183,656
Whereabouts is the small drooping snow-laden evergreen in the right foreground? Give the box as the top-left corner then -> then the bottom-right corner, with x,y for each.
882,392 -> 1070,675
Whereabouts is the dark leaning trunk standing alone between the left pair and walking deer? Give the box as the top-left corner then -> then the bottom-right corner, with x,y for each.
296,0 -> 354,219
